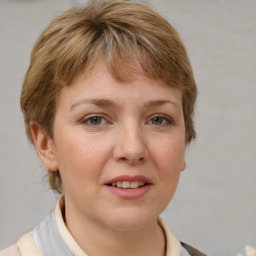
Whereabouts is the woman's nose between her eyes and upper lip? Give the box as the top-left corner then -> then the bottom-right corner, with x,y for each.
113,125 -> 149,164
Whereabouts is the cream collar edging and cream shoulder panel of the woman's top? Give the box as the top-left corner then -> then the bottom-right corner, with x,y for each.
0,199 -> 180,256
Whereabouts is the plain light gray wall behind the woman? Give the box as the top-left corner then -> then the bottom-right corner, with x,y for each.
0,0 -> 256,256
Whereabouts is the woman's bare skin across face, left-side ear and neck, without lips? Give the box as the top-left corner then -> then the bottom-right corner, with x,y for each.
30,63 -> 185,256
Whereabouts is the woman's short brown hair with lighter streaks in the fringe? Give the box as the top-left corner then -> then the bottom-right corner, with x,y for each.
21,0 -> 197,192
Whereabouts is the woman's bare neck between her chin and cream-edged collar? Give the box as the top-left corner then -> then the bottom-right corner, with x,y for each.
65,200 -> 165,256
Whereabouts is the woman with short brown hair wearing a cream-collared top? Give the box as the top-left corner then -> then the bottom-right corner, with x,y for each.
0,0 -> 204,256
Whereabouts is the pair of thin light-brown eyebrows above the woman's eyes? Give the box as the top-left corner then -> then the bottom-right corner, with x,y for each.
70,99 -> 181,110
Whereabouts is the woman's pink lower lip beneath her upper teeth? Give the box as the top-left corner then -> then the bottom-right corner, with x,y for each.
106,185 -> 151,200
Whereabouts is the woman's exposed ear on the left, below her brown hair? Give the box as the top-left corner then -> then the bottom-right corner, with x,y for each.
29,122 -> 59,171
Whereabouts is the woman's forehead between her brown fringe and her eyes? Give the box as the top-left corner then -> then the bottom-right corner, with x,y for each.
57,62 -> 182,113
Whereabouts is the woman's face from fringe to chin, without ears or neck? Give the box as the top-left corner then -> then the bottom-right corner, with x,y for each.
46,63 -> 185,230
